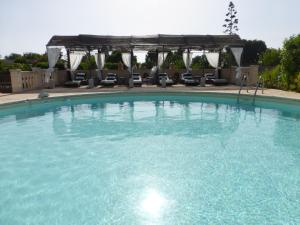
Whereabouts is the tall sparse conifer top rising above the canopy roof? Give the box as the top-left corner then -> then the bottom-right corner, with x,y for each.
223,2 -> 239,35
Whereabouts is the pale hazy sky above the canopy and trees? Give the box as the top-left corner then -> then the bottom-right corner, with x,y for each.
0,0 -> 300,57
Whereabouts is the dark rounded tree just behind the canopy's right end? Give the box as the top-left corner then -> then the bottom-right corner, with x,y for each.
242,40 -> 267,66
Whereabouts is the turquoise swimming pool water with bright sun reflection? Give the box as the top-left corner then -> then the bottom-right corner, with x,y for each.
0,95 -> 300,225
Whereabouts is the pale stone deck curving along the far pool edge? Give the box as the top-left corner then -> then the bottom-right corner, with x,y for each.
0,85 -> 300,105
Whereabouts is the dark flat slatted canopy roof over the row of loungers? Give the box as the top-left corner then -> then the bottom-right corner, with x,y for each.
47,34 -> 243,51
